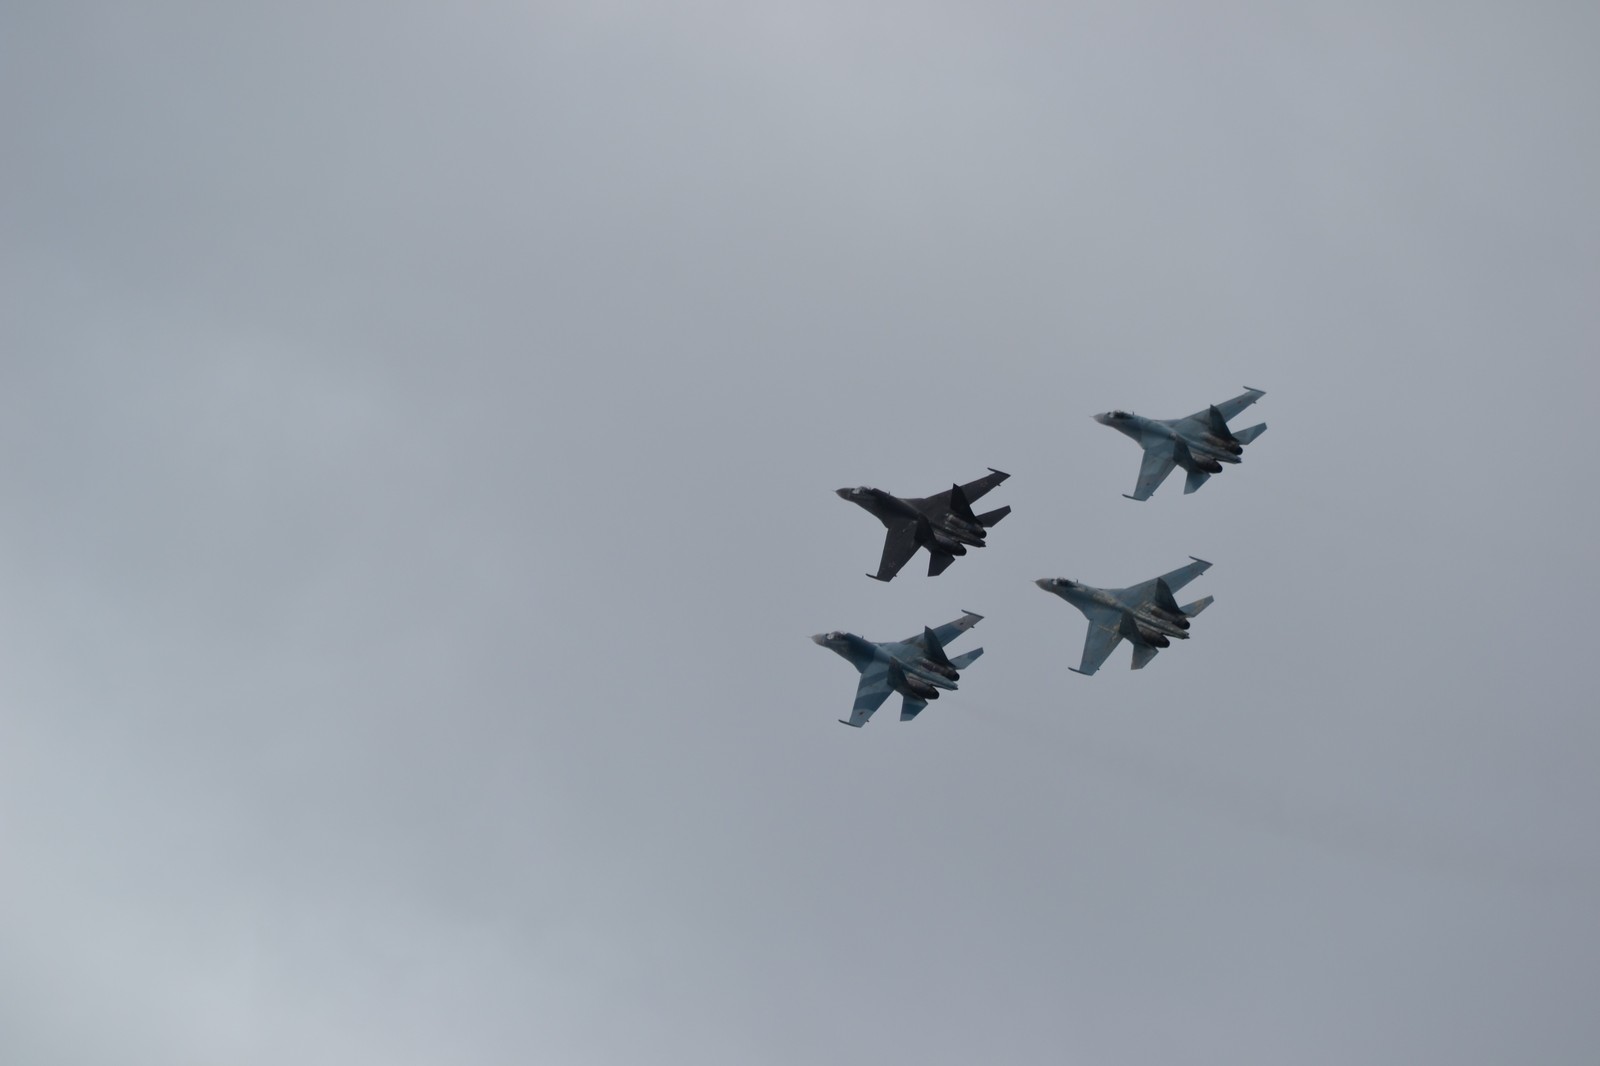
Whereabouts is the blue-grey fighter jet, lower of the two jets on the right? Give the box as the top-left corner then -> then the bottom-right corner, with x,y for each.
1034,555 -> 1211,674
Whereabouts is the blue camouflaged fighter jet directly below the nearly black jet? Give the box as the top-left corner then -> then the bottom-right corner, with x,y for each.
811,611 -> 984,728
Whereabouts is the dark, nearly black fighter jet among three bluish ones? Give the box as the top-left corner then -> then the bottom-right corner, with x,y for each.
835,466 -> 1011,581
